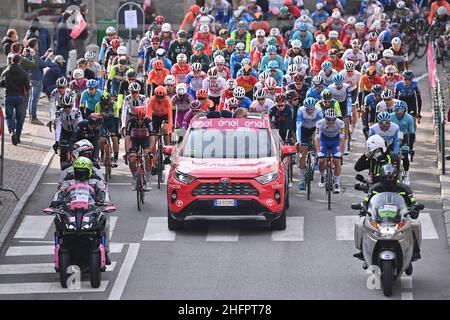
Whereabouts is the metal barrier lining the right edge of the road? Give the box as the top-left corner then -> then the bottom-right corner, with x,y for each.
433,78 -> 445,175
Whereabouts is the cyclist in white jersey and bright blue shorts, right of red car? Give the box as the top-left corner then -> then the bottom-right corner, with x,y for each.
316,108 -> 345,193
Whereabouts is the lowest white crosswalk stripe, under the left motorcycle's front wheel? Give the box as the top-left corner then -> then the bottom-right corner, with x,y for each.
0,281 -> 109,294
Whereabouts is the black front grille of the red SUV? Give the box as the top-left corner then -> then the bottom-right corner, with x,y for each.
192,183 -> 259,197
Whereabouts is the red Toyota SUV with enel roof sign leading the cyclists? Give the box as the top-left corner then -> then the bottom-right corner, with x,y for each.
165,115 -> 296,230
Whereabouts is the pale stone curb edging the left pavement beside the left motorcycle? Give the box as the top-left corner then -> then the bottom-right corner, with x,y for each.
0,149 -> 55,250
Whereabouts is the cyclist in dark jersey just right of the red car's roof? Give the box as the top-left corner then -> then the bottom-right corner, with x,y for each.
269,93 -> 295,142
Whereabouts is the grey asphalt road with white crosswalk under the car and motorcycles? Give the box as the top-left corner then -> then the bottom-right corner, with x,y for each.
0,55 -> 450,300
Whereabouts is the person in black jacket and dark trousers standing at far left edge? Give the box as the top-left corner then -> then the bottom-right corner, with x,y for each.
0,54 -> 30,145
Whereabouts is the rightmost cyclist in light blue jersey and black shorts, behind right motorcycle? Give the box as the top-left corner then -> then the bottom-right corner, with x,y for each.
391,101 -> 416,185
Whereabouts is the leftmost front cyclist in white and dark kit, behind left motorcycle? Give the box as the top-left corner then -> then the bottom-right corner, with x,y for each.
53,95 -> 83,169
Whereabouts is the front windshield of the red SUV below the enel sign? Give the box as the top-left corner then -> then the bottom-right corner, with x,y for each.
182,128 -> 275,159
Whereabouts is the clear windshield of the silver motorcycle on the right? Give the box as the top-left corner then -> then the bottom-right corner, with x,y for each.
369,192 -> 408,222
